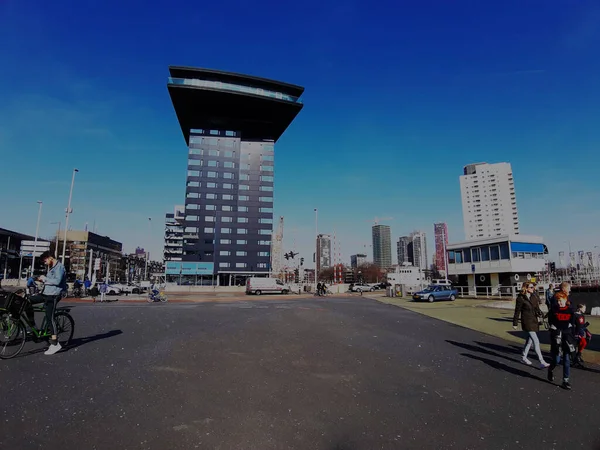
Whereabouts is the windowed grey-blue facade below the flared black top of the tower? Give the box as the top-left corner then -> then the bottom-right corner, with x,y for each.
183,130 -> 274,272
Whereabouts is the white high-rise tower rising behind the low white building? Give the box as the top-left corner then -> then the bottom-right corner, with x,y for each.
460,163 -> 519,240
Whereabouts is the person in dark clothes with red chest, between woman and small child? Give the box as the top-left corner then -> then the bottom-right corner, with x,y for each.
548,291 -> 576,389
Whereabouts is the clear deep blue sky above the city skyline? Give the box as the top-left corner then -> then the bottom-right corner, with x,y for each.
0,0 -> 600,262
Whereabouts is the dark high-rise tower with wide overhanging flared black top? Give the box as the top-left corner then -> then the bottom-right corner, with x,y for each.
166,67 -> 304,284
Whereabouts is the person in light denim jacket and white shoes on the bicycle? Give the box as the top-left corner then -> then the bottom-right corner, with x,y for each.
27,251 -> 67,355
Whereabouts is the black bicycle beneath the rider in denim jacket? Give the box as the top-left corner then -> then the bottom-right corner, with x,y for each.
0,290 -> 75,359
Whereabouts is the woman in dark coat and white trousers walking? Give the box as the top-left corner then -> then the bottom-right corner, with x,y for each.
513,282 -> 550,369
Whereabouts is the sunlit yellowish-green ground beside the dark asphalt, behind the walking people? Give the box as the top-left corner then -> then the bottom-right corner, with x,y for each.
368,295 -> 600,364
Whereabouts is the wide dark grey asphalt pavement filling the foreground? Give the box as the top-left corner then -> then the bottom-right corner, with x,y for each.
0,297 -> 600,450
